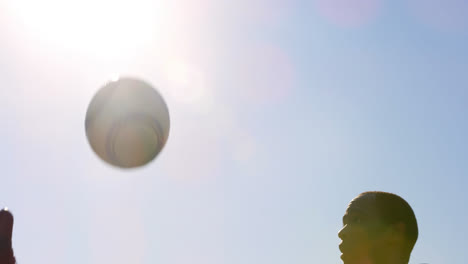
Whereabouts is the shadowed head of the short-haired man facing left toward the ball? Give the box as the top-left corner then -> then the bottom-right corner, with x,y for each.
338,192 -> 418,264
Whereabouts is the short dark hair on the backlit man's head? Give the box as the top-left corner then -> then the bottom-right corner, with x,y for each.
358,191 -> 418,259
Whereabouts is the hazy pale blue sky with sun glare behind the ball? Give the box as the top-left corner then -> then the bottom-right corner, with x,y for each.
0,0 -> 468,264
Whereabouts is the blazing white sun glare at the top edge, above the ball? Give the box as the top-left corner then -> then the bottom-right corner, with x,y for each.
7,0 -> 165,58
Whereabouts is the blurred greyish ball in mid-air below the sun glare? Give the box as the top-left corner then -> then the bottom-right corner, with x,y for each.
85,78 -> 170,168
